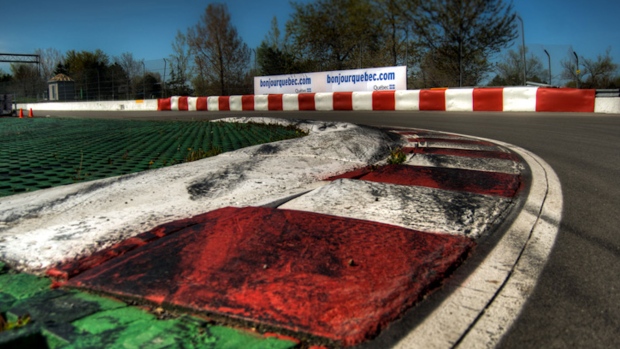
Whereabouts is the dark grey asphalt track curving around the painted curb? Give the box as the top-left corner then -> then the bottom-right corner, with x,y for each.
36,111 -> 620,348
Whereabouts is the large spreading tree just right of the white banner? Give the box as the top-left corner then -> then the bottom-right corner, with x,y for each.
407,0 -> 517,87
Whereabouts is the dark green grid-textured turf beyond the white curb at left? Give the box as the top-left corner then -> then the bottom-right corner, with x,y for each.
0,118 -> 304,197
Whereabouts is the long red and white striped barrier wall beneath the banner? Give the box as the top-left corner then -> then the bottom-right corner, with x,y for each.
157,87 -> 620,113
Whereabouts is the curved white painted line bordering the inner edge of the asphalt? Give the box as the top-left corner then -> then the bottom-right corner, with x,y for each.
394,135 -> 562,348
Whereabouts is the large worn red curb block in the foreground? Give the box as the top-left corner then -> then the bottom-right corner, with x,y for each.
60,207 -> 475,345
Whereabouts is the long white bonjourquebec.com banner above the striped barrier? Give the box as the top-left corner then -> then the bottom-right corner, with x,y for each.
254,66 -> 407,95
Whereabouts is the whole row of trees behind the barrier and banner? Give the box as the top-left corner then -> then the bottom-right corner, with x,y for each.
0,0 -> 620,99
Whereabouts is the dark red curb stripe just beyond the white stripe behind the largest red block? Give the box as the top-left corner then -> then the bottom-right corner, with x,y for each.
327,165 -> 521,198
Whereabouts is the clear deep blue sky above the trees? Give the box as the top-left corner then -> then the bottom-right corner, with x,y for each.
0,0 -> 620,82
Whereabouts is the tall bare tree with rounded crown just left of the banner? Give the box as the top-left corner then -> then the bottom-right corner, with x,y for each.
187,4 -> 250,95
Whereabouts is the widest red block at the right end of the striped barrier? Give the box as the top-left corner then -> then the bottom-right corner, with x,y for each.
536,88 -> 596,113
